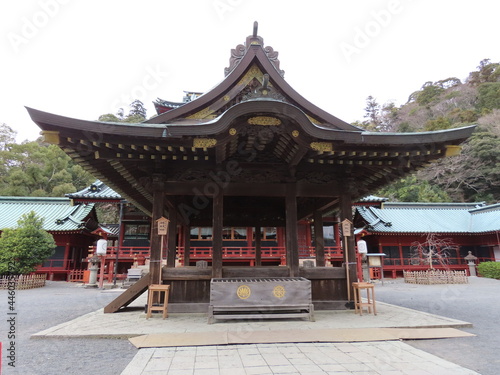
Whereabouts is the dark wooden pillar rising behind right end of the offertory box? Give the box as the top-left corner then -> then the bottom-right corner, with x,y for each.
285,184 -> 299,277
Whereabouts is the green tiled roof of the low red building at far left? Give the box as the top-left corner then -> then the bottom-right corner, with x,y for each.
0,197 -> 95,232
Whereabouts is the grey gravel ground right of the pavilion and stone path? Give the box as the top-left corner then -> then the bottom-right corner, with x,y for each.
376,277 -> 500,375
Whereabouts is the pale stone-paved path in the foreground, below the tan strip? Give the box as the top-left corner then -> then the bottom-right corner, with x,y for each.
122,341 -> 477,375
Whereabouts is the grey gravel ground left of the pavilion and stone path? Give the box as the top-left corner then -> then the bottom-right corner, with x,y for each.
0,282 -> 137,375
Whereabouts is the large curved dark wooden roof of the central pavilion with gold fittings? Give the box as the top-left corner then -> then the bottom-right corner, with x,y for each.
24,26 -> 474,218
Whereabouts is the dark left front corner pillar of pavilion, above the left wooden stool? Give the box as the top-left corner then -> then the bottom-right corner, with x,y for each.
149,176 -> 165,284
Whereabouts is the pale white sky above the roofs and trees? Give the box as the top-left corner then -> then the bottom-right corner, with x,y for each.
0,0 -> 500,141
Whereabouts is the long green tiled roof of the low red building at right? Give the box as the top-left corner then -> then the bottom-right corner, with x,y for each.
357,202 -> 500,233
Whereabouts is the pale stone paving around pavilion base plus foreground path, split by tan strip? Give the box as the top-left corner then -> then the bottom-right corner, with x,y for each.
32,290 -> 477,375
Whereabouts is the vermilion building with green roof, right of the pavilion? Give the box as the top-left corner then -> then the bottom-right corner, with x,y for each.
355,199 -> 500,277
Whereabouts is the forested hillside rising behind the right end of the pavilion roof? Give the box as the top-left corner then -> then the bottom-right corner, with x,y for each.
355,60 -> 500,203
